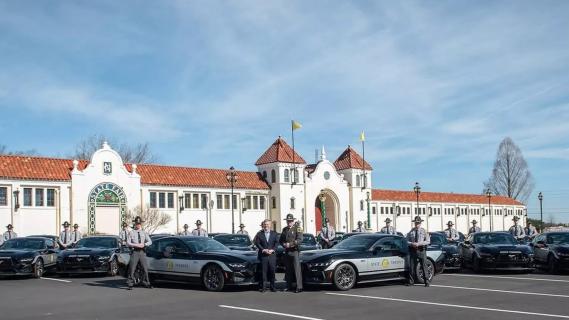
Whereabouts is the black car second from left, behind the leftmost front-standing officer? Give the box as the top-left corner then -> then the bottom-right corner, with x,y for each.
57,236 -> 129,276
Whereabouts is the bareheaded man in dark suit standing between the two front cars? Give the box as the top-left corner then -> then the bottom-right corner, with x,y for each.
254,219 -> 279,292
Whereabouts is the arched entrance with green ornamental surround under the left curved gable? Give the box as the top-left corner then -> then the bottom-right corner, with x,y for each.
88,182 -> 127,234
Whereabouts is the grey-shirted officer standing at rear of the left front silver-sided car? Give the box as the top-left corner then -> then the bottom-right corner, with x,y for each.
127,217 -> 152,290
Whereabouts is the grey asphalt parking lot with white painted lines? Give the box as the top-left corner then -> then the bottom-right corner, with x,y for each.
0,272 -> 569,320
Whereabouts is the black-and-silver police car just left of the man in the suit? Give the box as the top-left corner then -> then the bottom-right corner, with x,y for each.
146,236 -> 259,291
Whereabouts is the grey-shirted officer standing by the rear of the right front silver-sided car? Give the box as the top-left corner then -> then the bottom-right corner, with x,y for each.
407,216 -> 431,287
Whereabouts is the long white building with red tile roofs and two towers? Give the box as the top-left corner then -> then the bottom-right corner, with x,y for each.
0,137 -> 526,236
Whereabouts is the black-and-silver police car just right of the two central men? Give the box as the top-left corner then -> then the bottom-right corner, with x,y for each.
301,233 -> 434,290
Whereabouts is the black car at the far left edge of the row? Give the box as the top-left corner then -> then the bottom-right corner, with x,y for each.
0,237 -> 59,278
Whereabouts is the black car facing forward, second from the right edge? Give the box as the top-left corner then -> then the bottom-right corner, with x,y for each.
459,232 -> 534,272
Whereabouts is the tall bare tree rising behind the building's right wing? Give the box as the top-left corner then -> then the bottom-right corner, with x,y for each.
484,137 -> 534,203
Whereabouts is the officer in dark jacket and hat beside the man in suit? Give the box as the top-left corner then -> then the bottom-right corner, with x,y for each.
279,213 -> 302,293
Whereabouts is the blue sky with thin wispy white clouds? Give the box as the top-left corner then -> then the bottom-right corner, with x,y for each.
0,0 -> 569,222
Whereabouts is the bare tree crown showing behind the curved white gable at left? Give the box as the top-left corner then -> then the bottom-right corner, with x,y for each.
72,135 -> 157,163
